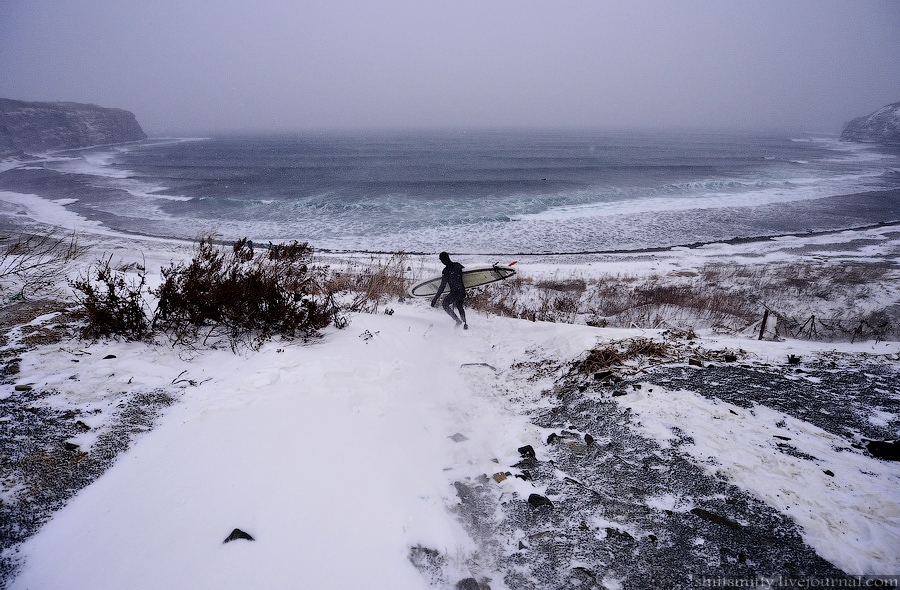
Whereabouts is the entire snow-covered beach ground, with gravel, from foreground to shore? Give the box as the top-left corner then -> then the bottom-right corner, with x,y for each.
0,193 -> 900,590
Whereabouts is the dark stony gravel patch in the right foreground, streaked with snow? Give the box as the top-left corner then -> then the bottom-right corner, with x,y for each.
411,356 -> 900,590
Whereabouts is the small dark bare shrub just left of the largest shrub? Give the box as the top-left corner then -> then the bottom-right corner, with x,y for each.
69,255 -> 151,340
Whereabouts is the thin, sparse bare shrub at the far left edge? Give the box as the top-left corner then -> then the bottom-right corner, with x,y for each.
0,229 -> 82,299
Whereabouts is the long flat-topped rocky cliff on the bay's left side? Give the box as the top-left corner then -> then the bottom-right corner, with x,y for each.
0,98 -> 147,154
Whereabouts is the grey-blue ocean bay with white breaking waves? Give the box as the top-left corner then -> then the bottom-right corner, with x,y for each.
0,131 -> 900,255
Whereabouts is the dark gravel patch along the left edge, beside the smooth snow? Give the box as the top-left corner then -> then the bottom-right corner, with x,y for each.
0,301 -> 175,589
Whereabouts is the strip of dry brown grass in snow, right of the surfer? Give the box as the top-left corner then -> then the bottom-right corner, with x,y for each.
469,262 -> 900,340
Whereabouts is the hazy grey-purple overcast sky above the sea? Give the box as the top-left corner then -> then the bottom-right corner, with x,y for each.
0,0 -> 900,135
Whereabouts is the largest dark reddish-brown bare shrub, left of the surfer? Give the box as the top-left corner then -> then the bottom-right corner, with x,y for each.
153,238 -> 339,349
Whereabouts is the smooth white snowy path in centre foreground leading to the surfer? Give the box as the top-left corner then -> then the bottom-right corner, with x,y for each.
13,305 -> 596,589
